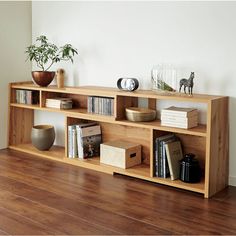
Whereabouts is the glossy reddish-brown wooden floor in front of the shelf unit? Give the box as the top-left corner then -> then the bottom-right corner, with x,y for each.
0,150 -> 236,235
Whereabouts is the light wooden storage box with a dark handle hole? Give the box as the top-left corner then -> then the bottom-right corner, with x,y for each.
100,140 -> 141,169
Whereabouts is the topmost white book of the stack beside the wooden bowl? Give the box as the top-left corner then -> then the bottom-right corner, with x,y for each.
161,106 -> 198,117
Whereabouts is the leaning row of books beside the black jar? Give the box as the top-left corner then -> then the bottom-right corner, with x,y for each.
154,134 -> 183,180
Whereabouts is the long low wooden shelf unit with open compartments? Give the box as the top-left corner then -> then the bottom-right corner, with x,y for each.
8,82 -> 229,198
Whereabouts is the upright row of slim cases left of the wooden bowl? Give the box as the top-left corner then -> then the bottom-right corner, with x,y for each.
88,96 -> 114,116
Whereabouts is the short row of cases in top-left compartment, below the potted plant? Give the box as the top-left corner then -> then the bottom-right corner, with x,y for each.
16,89 -> 39,105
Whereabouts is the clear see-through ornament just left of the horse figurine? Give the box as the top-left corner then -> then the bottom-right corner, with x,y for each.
151,64 -> 177,93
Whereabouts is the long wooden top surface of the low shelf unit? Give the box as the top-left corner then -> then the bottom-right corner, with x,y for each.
11,81 -> 224,103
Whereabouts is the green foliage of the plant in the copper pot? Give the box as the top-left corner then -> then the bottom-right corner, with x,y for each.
25,35 -> 78,71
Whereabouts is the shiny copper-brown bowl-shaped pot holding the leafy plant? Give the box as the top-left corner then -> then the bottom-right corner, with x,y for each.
31,71 -> 55,87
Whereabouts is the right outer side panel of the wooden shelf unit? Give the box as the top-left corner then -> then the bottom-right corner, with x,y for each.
207,97 -> 229,196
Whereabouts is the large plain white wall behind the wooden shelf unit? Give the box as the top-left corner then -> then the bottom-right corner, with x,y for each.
32,1 -> 236,185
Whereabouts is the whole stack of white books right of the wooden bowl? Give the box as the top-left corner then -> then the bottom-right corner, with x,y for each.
161,106 -> 198,129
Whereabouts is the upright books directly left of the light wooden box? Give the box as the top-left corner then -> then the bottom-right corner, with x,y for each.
68,122 -> 102,159
